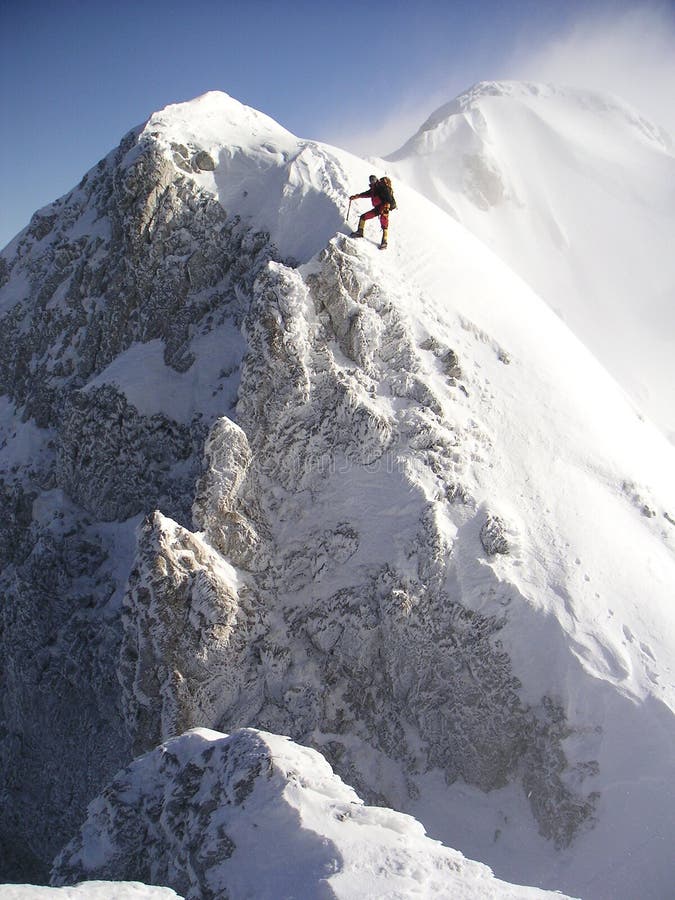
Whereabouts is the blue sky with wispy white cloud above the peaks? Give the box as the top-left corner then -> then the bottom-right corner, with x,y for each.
0,0 -> 675,247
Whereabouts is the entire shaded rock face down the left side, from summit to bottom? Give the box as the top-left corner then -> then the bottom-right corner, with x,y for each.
0,121 -> 275,880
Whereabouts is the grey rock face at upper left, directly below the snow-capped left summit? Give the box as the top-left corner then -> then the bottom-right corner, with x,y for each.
0,133 -> 273,427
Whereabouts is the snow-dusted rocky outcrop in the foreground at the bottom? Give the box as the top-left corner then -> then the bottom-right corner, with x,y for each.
52,729 -> 576,900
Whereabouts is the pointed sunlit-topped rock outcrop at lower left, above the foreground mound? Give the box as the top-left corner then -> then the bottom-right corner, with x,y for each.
118,512 -> 263,753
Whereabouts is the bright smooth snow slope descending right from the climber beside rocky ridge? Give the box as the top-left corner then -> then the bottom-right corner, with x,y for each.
334,194 -> 675,898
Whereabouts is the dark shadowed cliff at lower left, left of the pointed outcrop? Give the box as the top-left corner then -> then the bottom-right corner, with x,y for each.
0,488 -> 128,880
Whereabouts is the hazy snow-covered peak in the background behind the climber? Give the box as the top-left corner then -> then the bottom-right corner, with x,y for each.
386,82 -> 675,440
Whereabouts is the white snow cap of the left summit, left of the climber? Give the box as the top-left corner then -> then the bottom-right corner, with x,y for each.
127,91 -> 362,262
